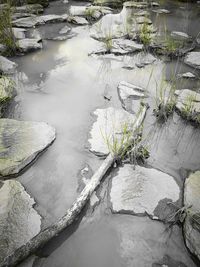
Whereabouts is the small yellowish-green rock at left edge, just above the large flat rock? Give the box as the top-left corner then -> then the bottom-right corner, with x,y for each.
0,77 -> 15,117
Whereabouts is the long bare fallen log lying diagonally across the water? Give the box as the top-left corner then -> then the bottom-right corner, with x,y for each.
0,105 -> 147,267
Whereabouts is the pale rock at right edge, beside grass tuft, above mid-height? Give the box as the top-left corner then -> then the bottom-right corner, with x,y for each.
175,89 -> 200,114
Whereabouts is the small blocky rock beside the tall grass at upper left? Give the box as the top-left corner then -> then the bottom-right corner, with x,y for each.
18,38 -> 42,53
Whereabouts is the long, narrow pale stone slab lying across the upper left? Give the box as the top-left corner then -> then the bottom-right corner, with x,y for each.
13,14 -> 68,28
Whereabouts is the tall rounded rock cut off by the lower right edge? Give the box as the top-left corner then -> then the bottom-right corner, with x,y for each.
184,171 -> 200,260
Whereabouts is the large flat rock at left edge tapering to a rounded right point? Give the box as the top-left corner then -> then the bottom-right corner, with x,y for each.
0,119 -> 55,176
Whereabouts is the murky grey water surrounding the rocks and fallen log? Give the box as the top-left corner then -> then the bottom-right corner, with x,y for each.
10,1 -> 200,267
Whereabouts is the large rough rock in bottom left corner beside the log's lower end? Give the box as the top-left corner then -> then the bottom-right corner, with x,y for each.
0,180 -> 41,264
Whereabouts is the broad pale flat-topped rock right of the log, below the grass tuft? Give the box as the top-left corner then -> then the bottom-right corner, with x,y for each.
110,165 -> 180,219
